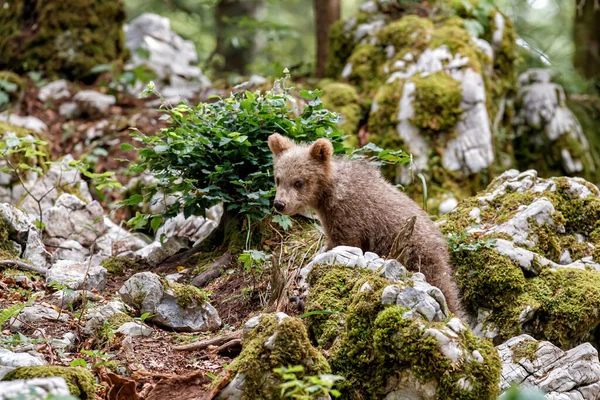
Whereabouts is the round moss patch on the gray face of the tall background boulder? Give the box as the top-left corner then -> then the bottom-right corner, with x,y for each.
411,72 -> 462,133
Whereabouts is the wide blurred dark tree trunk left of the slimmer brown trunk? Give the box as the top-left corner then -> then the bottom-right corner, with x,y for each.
215,0 -> 262,75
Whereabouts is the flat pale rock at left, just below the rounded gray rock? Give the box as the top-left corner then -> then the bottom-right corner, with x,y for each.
46,260 -> 108,291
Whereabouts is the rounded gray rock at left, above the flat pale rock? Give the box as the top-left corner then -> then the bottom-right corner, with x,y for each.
43,193 -> 106,247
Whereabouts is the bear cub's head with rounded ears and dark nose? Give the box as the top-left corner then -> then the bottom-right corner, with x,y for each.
269,133 -> 333,215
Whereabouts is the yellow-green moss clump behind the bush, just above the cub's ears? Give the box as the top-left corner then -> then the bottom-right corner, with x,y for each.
321,82 -> 362,136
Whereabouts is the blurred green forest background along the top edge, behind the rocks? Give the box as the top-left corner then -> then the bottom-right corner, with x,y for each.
125,0 -> 600,93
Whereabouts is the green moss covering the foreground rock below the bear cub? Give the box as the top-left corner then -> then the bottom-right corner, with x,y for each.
307,265 -> 500,399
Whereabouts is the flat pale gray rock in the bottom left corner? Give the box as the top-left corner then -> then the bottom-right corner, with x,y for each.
0,377 -> 71,400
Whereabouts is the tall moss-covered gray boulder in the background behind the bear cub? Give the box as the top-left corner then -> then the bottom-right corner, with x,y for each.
329,1 -> 516,198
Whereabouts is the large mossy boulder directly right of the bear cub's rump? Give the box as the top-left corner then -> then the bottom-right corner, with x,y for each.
440,170 -> 600,348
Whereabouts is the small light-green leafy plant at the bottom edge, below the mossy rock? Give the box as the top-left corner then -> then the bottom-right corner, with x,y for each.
273,365 -> 344,400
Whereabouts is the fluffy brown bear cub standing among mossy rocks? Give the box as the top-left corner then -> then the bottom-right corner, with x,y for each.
269,133 -> 464,316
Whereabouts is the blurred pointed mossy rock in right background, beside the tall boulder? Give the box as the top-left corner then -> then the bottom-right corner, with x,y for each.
513,69 -> 598,182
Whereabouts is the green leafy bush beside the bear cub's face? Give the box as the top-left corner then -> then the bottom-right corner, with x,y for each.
122,75 -> 408,228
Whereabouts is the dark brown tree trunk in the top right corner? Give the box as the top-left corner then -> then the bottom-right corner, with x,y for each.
574,0 -> 600,79
